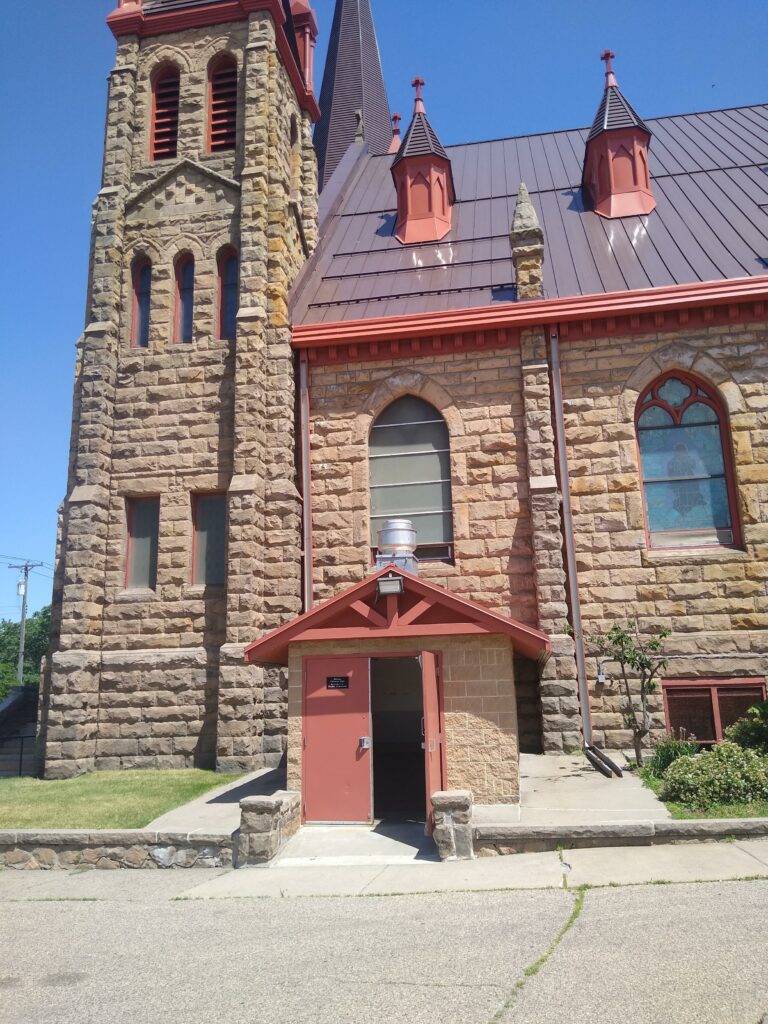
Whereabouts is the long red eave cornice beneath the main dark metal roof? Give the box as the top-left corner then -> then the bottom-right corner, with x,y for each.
293,274 -> 768,362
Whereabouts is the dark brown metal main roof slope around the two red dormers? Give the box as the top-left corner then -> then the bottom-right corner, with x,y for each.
292,104 -> 768,324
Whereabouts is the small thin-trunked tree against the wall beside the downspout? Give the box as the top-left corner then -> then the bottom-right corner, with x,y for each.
587,622 -> 672,765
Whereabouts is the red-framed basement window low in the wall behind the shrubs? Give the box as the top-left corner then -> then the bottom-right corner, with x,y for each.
662,676 -> 766,746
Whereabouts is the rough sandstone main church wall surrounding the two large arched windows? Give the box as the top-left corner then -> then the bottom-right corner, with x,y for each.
310,325 -> 768,751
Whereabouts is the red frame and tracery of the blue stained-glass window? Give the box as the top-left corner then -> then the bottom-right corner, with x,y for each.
635,370 -> 743,551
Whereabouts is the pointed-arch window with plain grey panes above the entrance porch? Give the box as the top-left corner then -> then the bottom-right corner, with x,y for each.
369,395 -> 454,560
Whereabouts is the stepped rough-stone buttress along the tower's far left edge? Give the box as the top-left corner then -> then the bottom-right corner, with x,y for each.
41,36 -> 138,778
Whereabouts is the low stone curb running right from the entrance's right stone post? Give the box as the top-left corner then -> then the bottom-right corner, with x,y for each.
472,818 -> 768,853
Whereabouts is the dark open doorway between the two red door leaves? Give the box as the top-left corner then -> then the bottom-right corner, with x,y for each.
371,657 -> 426,821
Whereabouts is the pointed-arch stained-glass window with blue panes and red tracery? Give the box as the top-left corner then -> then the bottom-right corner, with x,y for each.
636,371 -> 739,548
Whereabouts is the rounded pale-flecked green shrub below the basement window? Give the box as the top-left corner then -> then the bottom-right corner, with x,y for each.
662,742 -> 768,811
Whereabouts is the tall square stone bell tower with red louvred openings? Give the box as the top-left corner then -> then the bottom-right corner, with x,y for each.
40,0 -> 319,778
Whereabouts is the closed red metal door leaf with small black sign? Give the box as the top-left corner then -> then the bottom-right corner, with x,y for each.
302,657 -> 373,822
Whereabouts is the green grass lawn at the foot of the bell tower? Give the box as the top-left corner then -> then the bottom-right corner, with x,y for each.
0,769 -> 241,828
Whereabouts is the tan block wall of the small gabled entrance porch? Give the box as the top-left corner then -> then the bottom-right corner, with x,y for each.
288,636 -> 519,804
